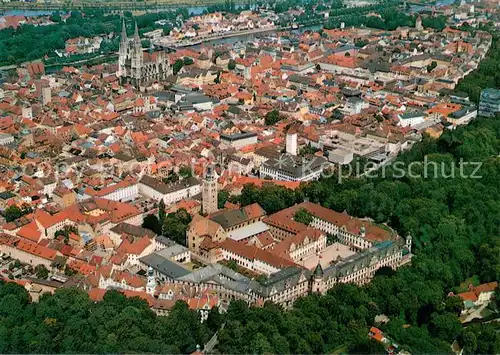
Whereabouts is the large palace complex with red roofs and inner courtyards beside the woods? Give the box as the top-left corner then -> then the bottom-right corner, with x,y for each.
142,202 -> 412,308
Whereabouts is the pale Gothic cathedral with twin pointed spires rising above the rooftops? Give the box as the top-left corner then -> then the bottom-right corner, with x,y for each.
117,20 -> 173,89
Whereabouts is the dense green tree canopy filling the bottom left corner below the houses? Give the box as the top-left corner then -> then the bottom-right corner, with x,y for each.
0,283 -> 212,354
